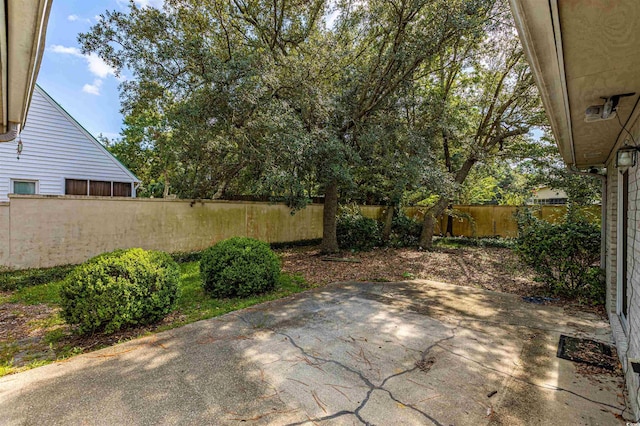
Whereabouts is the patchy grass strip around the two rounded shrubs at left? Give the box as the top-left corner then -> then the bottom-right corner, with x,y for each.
0,262 -> 309,377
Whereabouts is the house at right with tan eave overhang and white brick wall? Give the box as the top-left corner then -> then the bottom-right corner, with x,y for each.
510,0 -> 640,419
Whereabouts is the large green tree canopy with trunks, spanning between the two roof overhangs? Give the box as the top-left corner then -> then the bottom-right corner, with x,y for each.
79,0 -> 592,251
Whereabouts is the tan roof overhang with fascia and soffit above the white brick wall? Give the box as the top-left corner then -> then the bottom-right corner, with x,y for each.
510,0 -> 640,168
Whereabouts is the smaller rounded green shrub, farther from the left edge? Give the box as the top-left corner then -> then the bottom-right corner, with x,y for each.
200,237 -> 280,297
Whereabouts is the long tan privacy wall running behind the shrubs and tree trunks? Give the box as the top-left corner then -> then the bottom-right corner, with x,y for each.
0,195 -> 599,268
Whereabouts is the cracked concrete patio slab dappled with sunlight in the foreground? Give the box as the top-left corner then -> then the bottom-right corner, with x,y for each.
0,280 -> 625,425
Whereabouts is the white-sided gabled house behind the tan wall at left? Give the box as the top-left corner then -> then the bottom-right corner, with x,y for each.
0,86 -> 139,201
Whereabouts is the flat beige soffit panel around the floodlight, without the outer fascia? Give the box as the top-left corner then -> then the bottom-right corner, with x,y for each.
558,0 -> 640,167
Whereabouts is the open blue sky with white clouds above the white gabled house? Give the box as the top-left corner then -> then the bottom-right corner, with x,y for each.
36,0 -> 162,138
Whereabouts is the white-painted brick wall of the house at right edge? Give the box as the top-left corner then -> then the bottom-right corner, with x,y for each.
606,122 -> 640,418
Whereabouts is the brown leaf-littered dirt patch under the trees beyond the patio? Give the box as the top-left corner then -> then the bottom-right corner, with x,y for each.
280,247 -> 544,296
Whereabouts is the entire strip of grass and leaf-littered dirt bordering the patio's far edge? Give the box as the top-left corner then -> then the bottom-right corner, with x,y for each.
0,238 -> 601,375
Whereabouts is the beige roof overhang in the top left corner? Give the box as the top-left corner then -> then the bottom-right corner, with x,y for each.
0,0 -> 51,141
